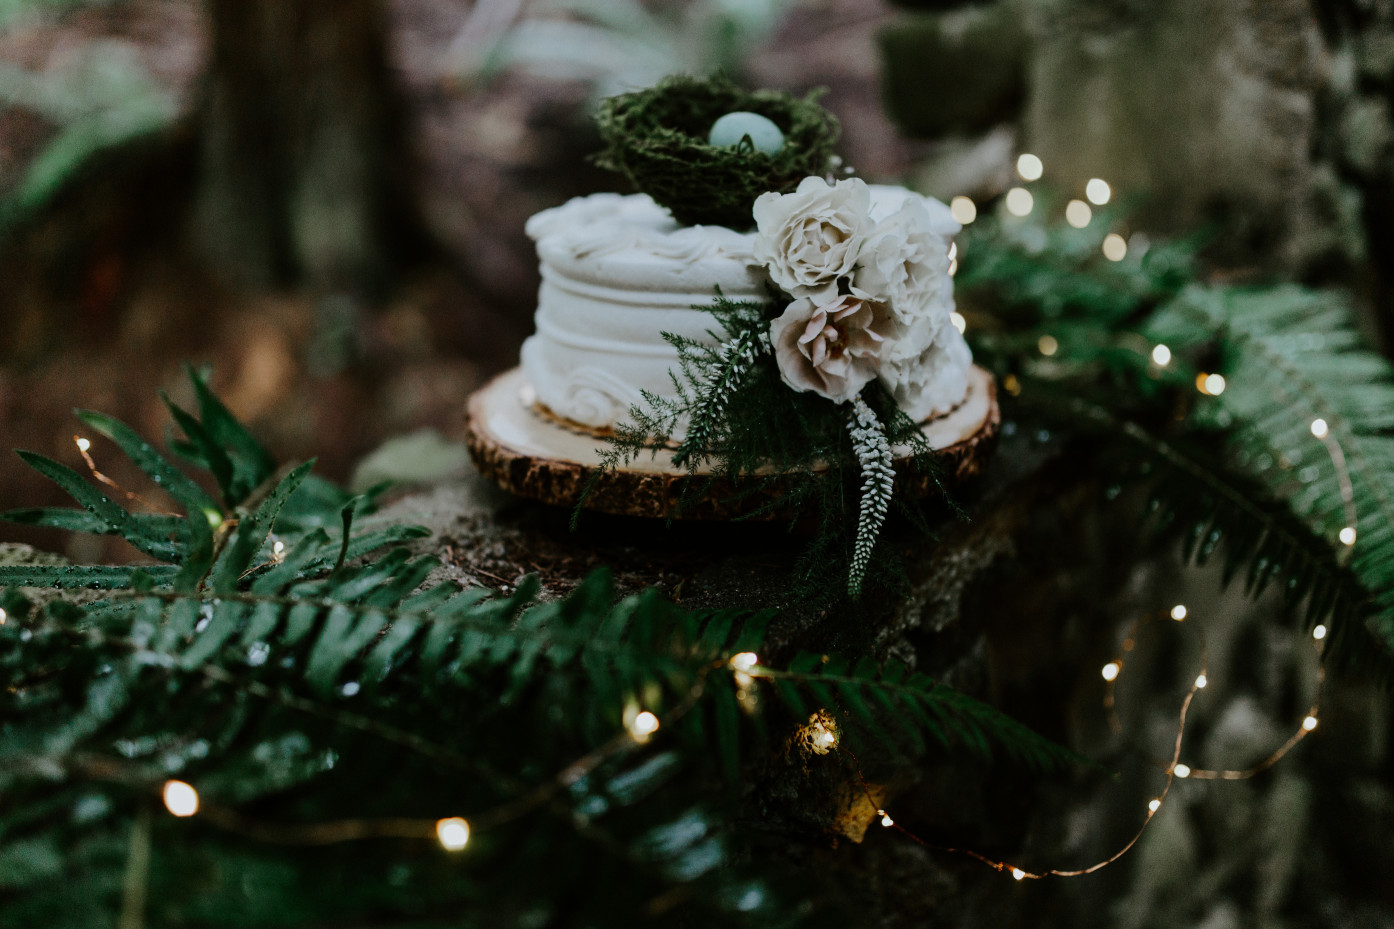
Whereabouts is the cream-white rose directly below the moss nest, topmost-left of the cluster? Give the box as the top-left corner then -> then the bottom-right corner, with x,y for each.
754,177 -> 871,290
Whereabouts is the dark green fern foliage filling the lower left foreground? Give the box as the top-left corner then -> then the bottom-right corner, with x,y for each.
0,381 -> 1064,929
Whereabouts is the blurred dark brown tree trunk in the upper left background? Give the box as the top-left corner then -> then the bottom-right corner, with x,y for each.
195,0 -> 421,292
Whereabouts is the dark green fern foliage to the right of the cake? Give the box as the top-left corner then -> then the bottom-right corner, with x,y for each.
958,197 -> 1394,674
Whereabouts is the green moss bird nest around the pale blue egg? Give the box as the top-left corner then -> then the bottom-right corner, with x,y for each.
595,77 -> 839,230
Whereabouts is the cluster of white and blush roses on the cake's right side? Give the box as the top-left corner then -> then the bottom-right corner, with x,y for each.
754,177 -> 972,420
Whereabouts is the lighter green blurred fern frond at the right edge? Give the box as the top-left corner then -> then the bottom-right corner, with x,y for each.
1154,286 -> 1394,653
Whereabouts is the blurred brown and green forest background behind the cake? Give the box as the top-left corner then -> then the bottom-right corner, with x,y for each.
0,0 -> 1394,559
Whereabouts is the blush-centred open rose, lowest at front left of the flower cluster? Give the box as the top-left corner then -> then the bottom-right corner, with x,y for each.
769,294 -> 889,403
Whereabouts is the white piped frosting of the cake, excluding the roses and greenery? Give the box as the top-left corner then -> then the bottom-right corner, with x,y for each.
523,186 -> 967,428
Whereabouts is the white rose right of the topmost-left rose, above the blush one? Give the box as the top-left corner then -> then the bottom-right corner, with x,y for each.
853,194 -> 956,357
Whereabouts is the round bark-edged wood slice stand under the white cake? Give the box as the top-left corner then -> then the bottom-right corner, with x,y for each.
466,367 -> 1001,519
